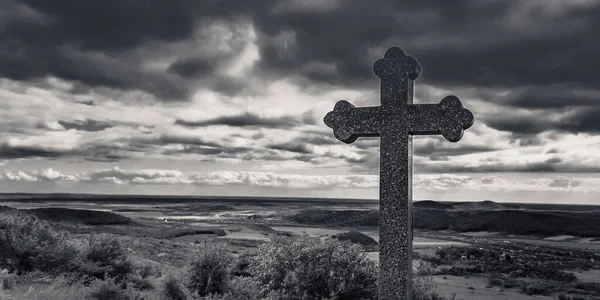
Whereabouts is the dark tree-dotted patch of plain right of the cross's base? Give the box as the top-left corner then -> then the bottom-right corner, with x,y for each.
419,240 -> 600,299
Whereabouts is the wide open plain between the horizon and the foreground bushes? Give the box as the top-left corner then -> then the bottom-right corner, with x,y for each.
0,194 -> 600,299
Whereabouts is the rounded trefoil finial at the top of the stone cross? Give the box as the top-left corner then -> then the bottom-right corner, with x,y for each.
373,47 -> 421,80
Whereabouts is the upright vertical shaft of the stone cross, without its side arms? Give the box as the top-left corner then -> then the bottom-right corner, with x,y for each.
374,48 -> 420,299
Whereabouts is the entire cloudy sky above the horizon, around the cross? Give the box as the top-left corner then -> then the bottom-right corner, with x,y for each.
0,0 -> 600,203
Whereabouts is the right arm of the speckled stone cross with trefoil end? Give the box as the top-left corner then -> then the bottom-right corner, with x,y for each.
403,96 -> 474,142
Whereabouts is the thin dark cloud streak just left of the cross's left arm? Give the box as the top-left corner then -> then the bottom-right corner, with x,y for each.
175,113 -> 300,128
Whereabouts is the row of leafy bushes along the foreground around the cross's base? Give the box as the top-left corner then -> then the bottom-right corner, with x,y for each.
0,211 -> 450,300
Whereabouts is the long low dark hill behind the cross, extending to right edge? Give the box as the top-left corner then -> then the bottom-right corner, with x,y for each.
289,201 -> 600,237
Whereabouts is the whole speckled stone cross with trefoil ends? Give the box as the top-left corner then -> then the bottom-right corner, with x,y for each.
324,47 -> 474,300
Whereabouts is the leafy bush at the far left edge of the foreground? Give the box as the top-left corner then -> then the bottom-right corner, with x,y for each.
0,211 -> 77,274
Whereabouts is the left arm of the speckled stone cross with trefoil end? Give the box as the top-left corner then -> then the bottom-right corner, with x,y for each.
323,100 -> 383,144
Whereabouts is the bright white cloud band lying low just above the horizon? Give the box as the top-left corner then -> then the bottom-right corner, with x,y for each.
0,167 -> 600,197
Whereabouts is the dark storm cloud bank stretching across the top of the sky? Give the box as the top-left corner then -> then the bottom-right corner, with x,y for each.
0,0 -> 600,94
